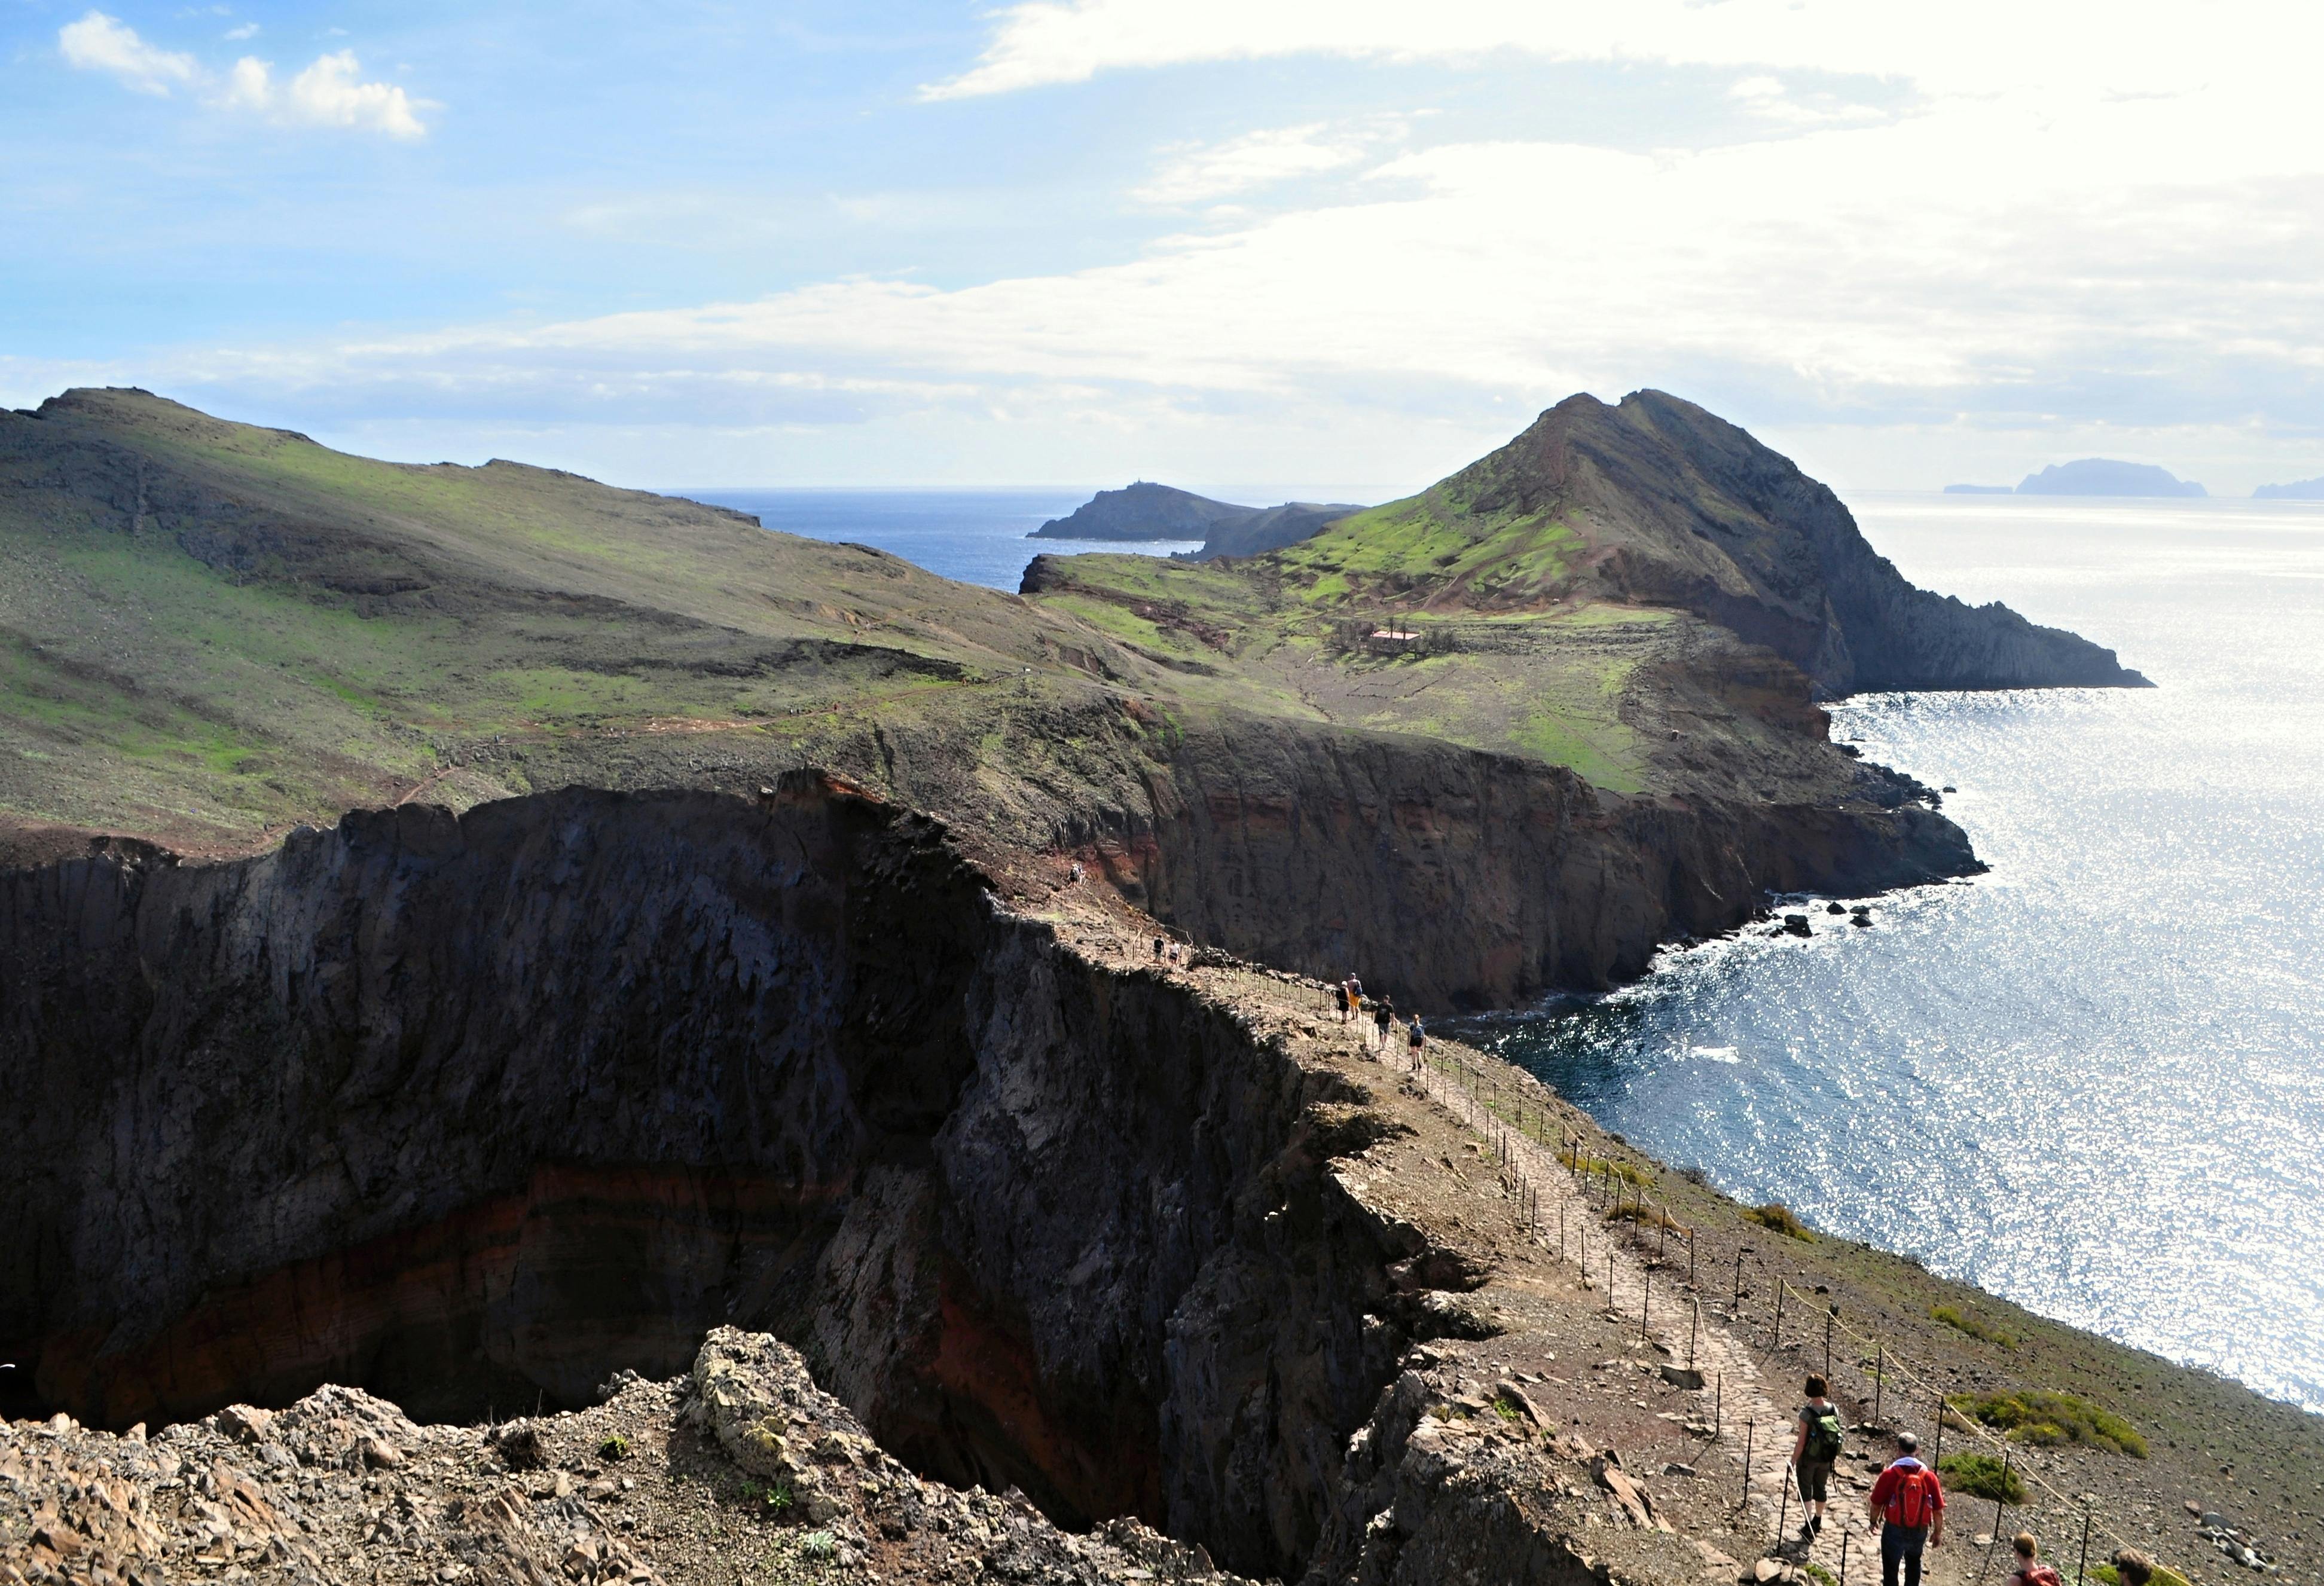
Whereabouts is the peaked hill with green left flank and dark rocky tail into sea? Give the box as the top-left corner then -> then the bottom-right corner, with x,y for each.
1078,390 -> 2145,696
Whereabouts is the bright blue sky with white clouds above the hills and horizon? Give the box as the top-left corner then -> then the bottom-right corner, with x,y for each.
0,0 -> 2324,499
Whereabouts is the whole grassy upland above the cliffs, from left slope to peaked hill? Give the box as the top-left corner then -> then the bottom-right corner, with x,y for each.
0,390 -> 2133,868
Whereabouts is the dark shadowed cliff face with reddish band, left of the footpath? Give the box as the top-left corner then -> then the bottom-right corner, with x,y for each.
0,775 -> 1413,1572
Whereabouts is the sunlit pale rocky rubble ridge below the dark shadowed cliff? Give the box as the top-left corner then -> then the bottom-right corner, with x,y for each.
0,1328 -> 1264,1586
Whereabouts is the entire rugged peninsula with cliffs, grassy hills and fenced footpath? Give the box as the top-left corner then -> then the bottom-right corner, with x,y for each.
0,392 -> 2286,1586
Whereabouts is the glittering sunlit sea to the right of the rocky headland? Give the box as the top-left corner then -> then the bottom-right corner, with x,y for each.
1467,497 -> 2324,1410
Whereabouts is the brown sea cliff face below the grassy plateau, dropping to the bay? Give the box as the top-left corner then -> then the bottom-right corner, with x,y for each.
1067,722 -> 1983,1008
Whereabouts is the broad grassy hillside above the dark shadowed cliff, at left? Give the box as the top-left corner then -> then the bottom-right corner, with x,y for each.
0,392 -> 1134,845
